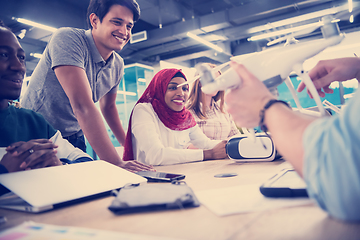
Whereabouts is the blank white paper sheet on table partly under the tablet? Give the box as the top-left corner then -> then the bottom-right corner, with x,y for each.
195,184 -> 313,216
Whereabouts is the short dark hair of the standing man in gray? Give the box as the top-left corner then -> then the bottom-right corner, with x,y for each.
87,0 -> 140,28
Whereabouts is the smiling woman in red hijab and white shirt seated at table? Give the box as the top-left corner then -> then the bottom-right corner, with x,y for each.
123,69 -> 227,165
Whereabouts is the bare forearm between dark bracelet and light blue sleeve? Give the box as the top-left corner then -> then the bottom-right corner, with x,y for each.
264,104 -> 316,176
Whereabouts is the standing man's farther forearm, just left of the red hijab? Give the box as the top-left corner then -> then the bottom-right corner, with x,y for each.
101,104 -> 125,146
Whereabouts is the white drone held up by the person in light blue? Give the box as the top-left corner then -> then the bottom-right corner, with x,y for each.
197,5 -> 358,139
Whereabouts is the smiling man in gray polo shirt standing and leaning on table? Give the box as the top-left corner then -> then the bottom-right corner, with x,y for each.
21,0 -> 152,171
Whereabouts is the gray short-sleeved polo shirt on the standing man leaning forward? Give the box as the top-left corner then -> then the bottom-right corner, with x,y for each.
21,28 -> 124,137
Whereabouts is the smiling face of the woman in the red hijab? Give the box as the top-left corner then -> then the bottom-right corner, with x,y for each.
165,77 -> 189,112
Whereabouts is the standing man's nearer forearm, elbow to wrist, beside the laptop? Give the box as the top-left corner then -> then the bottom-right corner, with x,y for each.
74,105 -> 121,165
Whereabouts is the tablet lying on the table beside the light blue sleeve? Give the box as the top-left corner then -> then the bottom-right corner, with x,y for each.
260,169 -> 308,197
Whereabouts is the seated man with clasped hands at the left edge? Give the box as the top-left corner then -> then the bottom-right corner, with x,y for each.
0,21 -> 92,182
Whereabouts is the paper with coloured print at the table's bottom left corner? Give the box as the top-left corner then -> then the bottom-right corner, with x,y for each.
0,222 -> 184,240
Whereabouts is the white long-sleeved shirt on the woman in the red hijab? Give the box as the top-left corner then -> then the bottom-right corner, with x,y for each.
131,103 -> 220,165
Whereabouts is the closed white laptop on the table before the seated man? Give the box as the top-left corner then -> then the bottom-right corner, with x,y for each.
0,160 -> 147,212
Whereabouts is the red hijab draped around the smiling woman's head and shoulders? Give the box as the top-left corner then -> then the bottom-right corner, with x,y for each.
123,68 -> 196,161
